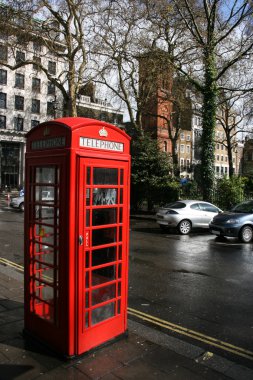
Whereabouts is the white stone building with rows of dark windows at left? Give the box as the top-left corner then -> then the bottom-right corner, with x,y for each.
0,36 -> 64,188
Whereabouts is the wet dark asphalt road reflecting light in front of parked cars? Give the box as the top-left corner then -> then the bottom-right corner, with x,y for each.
0,206 -> 253,366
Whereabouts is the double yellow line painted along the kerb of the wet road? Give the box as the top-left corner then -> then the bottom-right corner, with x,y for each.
0,257 -> 253,361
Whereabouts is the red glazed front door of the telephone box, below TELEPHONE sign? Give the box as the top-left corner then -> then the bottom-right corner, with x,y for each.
77,158 -> 129,354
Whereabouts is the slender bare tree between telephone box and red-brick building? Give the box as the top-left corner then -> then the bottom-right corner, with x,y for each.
89,0 -> 154,134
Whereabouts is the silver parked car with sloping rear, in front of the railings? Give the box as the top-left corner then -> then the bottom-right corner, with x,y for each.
156,200 -> 222,235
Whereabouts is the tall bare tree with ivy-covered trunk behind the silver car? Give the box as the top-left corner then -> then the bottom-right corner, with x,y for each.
146,0 -> 253,200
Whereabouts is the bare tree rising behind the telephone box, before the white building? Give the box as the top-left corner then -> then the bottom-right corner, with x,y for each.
0,0 -> 98,116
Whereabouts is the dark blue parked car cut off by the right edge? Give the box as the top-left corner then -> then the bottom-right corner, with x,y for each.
209,200 -> 253,243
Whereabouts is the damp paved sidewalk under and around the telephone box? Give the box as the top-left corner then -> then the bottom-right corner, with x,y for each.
0,264 -> 253,380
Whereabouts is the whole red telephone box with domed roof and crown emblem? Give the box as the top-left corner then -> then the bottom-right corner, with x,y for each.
24,117 -> 130,357
